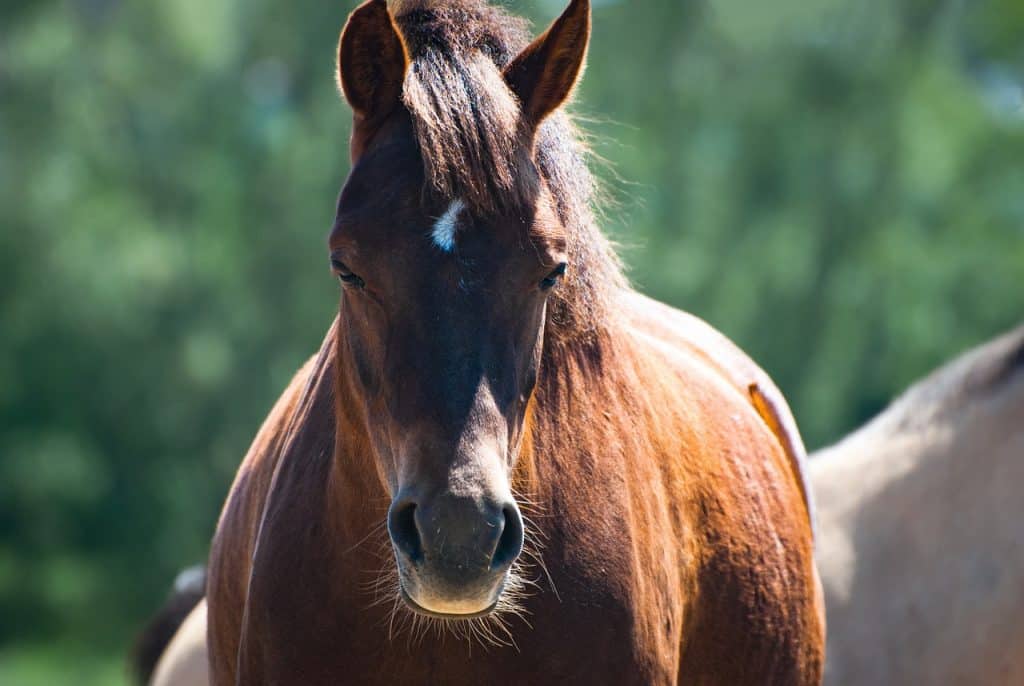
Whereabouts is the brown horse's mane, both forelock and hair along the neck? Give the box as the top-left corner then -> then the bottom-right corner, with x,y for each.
389,0 -> 626,341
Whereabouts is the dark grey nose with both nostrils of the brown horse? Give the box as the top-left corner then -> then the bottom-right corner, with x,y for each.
388,496 -> 523,581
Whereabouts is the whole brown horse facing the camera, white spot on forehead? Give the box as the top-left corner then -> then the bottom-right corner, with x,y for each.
201,0 -> 824,686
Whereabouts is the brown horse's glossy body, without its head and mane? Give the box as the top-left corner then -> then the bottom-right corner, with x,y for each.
209,294 -> 823,684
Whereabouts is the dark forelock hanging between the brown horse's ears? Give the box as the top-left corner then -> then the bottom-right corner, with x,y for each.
395,1 -> 528,213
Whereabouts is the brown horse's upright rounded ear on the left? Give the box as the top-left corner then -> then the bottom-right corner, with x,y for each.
337,0 -> 409,122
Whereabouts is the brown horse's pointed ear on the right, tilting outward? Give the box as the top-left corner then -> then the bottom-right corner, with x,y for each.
505,0 -> 590,127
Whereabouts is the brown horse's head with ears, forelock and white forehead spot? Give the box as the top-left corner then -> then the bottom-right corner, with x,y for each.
329,0 -> 590,617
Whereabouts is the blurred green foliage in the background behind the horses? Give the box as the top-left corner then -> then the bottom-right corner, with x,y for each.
0,0 -> 1024,686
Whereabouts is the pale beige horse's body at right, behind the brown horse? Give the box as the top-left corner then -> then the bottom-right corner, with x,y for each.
810,329 -> 1024,686
